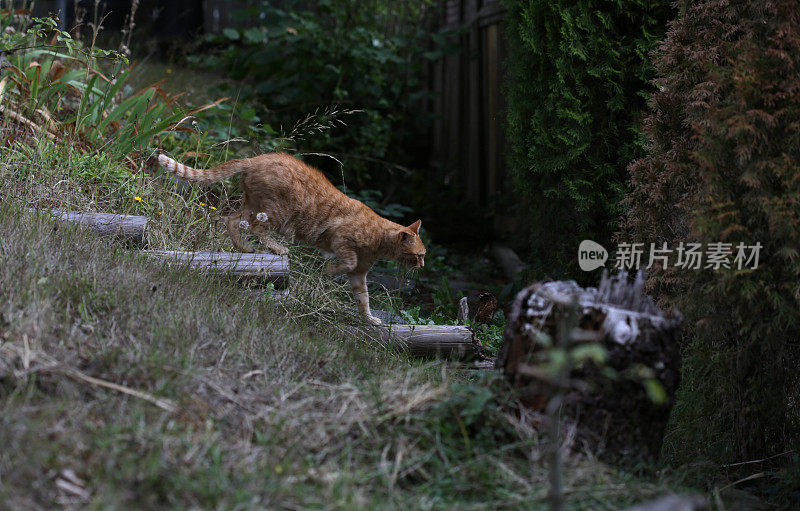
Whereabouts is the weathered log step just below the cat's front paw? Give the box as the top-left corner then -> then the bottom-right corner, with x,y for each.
378,325 -> 484,360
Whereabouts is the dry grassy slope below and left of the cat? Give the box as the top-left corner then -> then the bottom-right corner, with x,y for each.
0,144 -> 708,509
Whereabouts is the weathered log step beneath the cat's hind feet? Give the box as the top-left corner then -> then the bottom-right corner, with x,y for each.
141,250 -> 289,285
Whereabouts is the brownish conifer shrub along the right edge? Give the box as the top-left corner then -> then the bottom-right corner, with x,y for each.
621,0 -> 800,472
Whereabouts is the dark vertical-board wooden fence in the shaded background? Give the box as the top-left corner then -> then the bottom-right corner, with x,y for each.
432,0 -> 506,214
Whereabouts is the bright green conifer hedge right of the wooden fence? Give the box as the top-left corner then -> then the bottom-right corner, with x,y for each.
506,0 -> 672,275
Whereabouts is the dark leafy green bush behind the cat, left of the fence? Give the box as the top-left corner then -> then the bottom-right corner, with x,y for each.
190,0 -> 444,189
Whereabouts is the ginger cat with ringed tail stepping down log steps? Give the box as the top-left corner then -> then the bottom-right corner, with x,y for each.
158,153 -> 425,325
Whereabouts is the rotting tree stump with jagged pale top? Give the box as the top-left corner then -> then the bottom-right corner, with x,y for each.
495,272 -> 682,459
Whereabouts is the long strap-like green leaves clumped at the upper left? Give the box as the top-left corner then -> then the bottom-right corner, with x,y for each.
0,12 -> 218,158
